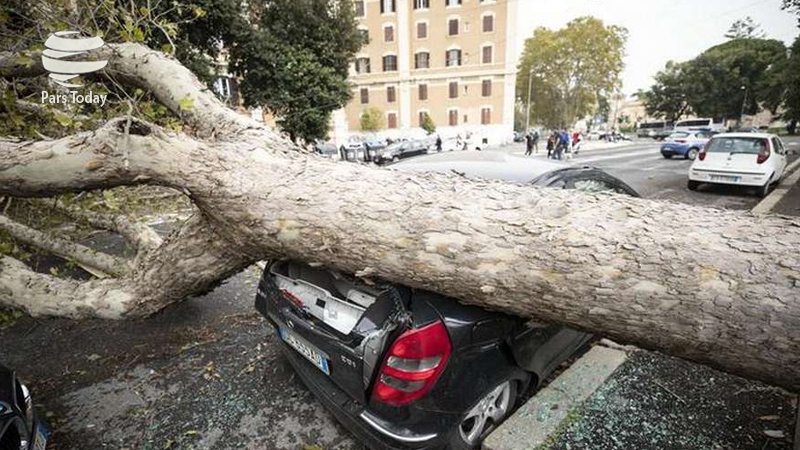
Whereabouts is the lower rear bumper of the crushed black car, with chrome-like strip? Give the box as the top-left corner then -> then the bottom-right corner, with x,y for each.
280,342 -> 444,450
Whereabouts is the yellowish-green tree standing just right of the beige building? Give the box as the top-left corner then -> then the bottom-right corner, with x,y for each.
516,17 -> 628,127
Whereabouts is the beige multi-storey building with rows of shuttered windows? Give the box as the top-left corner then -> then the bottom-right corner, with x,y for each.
334,0 -> 518,144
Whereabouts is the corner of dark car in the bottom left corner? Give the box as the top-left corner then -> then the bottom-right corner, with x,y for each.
0,365 -> 48,450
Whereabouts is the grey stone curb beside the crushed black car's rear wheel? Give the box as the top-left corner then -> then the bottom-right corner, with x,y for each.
483,343 -> 628,450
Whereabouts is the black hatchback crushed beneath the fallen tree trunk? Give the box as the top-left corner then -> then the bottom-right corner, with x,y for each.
255,152 -> 638,450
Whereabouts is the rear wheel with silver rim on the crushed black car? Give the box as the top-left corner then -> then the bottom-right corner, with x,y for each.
447,379 -> 519,450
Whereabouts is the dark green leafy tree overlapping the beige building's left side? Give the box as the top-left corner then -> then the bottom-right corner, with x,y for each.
231,0 -> 363,141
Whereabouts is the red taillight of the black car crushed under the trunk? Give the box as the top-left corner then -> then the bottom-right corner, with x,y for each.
372,321 -> 452,406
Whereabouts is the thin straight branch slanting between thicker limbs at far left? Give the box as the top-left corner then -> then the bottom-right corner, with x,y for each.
0,214 -> 130,276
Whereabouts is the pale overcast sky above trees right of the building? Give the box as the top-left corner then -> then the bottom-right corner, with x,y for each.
512,0 -> 800,95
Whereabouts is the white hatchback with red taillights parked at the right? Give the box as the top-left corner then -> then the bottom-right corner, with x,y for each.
687,133 -> 787,197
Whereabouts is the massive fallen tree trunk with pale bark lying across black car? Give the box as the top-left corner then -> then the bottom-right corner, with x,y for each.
0,44 -> 800,390
